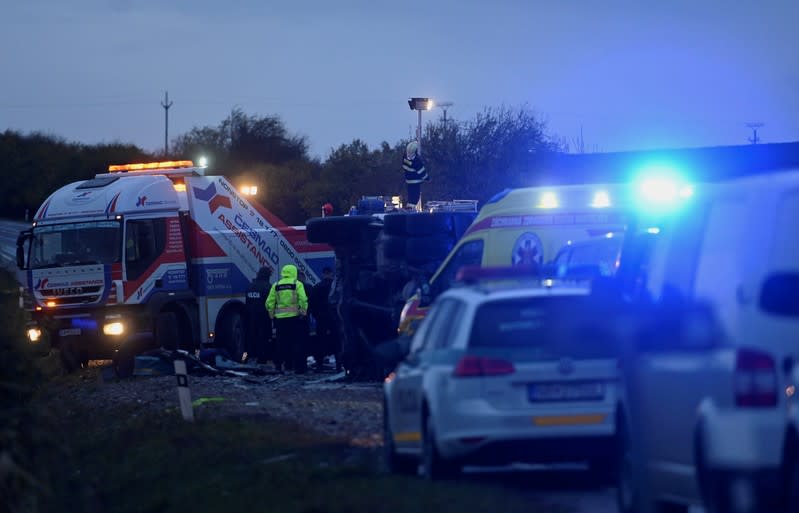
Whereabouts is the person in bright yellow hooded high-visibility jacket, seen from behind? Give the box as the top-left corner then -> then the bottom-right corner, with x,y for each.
266,264 -> 308,373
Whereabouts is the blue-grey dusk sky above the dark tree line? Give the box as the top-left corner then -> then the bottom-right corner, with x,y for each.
0,0 -> 799,158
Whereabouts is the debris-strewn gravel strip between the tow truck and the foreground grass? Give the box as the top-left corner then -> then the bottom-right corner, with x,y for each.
39,362 -> 383,447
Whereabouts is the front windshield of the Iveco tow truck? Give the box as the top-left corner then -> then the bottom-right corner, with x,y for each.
30,221 -> 122,269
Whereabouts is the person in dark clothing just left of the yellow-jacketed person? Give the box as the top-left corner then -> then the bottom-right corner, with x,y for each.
245,267 -> 274,363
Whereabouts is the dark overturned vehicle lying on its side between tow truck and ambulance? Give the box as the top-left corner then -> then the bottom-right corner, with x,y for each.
306,198 -> 477,380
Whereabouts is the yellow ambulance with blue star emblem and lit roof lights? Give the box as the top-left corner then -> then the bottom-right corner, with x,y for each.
398,177 -> 693,335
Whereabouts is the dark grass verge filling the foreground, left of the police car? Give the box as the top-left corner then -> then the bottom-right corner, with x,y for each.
0,271 -> 560,513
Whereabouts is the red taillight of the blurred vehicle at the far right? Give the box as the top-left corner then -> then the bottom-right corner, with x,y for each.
735,349 -> 777,408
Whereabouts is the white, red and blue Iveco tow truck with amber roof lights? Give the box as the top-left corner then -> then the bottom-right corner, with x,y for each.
17,161 -> 334,370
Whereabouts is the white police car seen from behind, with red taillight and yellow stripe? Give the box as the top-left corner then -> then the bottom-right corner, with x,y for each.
383,280 -> 618,479
